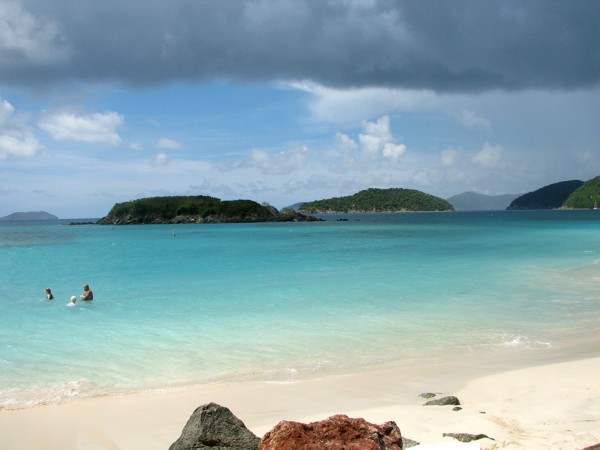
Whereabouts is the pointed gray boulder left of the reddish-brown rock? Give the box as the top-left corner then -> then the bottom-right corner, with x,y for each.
169,403 -> 260,450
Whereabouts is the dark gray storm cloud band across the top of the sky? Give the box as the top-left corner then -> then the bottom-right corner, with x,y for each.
0,0 -> 600,92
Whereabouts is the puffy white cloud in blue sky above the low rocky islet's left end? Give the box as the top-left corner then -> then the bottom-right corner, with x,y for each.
39,111 -> 123,145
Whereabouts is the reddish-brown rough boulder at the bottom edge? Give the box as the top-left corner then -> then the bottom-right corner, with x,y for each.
258,414 -> 402,450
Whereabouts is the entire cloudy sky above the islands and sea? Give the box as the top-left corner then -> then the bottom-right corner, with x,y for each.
0,0 -> 600,218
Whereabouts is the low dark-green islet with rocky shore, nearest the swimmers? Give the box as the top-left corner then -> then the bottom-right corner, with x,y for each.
97,195 -> 317,225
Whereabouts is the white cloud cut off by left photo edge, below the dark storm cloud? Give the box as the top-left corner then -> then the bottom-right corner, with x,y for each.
0,98 -> 42,159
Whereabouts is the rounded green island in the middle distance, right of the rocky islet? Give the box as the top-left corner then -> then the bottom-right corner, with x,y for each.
299,188 -> 454,214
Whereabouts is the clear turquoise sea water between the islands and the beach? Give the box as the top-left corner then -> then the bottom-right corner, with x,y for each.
0,211 -> 600,408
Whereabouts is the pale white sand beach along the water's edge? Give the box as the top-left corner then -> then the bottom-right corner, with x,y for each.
0,357 -> 600,450
